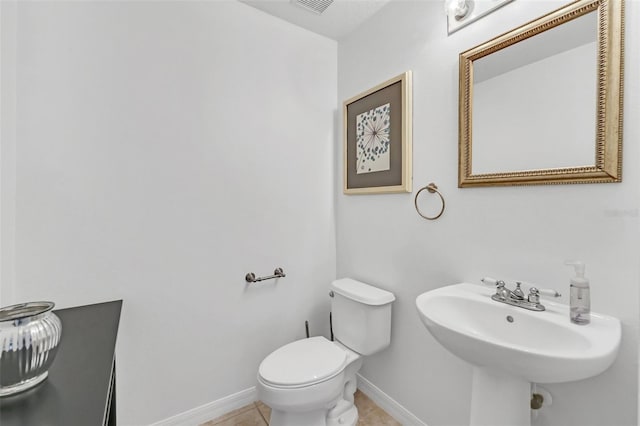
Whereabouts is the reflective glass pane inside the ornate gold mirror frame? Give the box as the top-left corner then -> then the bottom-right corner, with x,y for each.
471,12 -> 598,174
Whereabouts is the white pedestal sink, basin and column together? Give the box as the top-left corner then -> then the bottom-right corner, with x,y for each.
416,283 -> 621,426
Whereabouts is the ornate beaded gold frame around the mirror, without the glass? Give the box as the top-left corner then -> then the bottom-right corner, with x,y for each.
458,0 -> 624,188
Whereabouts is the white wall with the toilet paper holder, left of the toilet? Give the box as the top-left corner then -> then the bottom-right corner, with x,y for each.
2,1 -> 337,426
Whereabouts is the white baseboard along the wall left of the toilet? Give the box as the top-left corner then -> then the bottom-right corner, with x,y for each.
151,386 -> 257,426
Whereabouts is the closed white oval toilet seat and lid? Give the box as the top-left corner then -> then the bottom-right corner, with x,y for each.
258,336 -> 347,388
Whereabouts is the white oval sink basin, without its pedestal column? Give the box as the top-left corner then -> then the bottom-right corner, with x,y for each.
416,283 -> 620,383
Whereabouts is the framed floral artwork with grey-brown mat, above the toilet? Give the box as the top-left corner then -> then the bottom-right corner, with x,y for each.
343,71 -> 411,194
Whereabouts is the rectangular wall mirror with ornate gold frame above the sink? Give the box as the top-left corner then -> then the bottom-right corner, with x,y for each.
458,0 -> 624,188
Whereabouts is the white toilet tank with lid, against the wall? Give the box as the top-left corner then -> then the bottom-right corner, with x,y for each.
331,278 -> 396,355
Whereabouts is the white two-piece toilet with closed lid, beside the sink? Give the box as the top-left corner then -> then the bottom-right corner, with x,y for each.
257,278 -> 395,426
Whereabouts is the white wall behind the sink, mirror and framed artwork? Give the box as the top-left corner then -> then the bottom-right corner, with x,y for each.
336,0 -> 640,426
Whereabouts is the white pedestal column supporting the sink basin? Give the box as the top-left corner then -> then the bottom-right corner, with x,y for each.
469,366 -> 531,426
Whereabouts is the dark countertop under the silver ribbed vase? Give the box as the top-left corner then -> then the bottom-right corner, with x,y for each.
0,300 -> 122,426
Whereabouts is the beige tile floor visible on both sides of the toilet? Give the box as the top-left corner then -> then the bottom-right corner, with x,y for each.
200,390 -> 402,426
